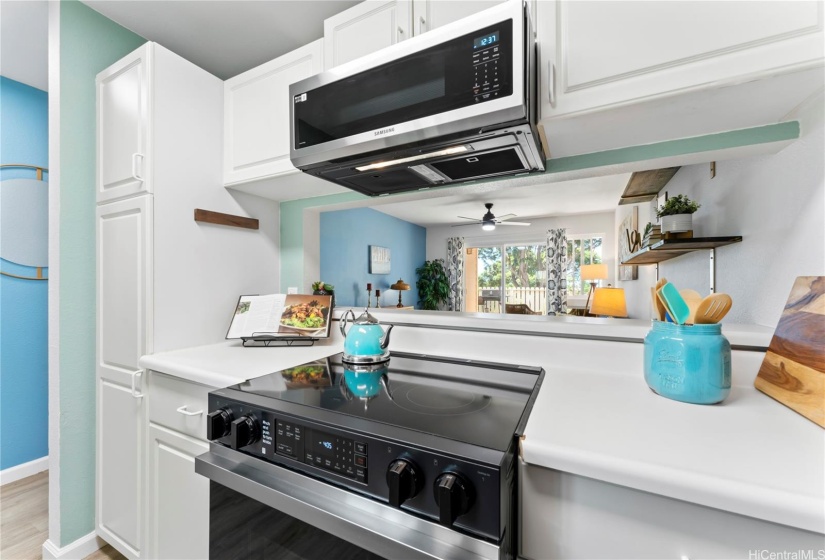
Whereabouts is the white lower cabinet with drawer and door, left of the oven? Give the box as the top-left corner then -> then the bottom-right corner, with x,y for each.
144,371 -> 210,560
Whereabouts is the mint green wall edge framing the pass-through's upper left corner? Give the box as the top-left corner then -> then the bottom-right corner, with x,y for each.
280,192 -> 368,293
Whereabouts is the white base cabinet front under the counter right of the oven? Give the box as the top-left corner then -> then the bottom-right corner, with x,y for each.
519,462 -> 825,560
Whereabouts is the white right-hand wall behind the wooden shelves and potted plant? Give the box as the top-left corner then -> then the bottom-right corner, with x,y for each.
616,97 -> 825,327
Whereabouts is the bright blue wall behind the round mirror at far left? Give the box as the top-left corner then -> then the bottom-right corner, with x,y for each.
0,76 -> 49,470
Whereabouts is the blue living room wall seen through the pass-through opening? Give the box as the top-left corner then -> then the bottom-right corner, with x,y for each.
318,208 -> 427,308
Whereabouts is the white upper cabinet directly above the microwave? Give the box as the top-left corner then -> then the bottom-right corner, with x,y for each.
324,0 -> 502,69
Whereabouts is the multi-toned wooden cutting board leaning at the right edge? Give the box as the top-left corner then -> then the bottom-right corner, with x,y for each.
754,276 -> 825,428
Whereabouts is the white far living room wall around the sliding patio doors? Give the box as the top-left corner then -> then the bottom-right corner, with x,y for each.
427,212 -> 616,303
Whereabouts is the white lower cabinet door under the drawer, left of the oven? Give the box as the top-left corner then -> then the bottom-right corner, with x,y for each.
146,423 -> 209,560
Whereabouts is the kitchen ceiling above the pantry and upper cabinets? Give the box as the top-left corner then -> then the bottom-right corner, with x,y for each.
83,0 -> 359,80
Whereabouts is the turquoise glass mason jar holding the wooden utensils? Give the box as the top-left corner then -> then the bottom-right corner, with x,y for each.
645,320 -> 730,404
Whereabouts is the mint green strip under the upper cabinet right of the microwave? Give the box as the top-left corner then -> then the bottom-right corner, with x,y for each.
545,121 -> 800,174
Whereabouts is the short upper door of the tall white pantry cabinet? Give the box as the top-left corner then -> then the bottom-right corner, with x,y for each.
96,43 -> 152,202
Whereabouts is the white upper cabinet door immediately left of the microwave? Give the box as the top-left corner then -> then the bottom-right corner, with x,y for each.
224,39 -> 323,185
